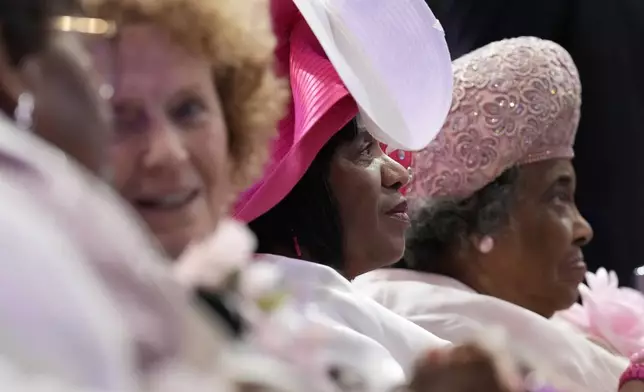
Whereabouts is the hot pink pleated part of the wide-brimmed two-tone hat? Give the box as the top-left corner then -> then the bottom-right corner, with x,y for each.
234,0 -> 358,222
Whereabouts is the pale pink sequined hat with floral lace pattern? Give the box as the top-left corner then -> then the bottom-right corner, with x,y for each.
410,37 -> 581,197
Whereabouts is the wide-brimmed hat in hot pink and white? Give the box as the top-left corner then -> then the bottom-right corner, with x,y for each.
234,0 -> 452,222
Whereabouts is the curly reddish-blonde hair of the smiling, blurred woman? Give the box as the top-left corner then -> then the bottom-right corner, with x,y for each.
81,0 -> 290,192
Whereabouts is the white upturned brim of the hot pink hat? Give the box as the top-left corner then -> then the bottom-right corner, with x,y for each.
294,0 -> 453,151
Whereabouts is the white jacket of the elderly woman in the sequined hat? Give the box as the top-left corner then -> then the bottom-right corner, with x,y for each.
353,269 -> 628,392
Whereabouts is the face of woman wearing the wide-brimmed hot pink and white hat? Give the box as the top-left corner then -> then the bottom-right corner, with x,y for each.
329,131 -> 409,277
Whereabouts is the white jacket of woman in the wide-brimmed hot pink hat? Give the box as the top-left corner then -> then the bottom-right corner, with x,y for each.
259,255 -> 450,390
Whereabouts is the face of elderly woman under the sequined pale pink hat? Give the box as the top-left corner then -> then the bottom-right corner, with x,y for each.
480,159 -> 593,317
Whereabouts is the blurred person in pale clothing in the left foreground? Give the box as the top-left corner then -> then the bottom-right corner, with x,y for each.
0,0 -> 294,391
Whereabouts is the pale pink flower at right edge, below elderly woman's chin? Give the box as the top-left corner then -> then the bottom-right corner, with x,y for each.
557,268 -> 644,357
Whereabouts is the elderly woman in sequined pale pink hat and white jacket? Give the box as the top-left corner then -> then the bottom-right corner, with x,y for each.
355,37 -> 626,392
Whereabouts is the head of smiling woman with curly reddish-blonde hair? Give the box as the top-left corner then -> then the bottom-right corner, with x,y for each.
82,0 -> 288,258
